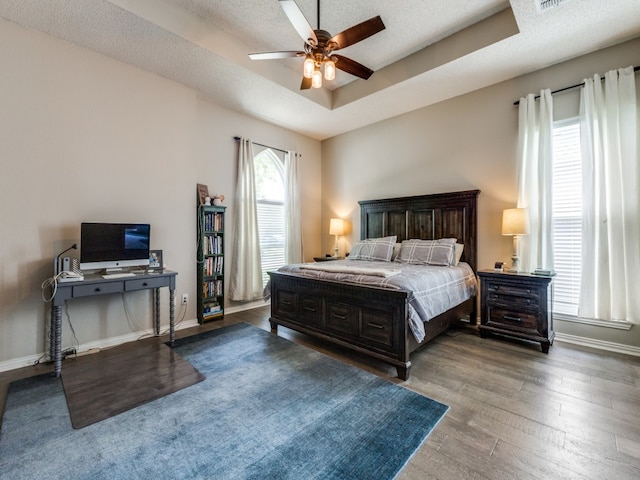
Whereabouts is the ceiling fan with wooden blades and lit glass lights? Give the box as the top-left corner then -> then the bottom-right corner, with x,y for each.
249,0 -> 385,90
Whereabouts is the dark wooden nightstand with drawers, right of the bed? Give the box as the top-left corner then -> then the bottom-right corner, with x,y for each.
478,270 -> 556,353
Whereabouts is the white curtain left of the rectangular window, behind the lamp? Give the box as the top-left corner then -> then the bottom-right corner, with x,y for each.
517,89 -> 553,272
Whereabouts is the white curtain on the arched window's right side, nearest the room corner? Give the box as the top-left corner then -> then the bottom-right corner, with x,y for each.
284,150 -> 303,263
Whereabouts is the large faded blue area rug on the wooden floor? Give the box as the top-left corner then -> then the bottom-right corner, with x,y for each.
0,324 -> 449,480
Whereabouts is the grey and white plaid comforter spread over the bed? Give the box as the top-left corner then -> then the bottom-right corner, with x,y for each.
265,260 -> 478,342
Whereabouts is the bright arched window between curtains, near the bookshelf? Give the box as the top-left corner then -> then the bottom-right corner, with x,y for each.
253,148 -> 285,285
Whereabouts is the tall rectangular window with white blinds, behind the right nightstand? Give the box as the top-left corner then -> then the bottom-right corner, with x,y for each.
552,119 -> 582,316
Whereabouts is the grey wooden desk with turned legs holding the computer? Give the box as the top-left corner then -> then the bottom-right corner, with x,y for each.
49,270 -> 178,377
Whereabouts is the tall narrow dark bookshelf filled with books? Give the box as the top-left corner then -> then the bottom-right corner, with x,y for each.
197,205 -> 226,323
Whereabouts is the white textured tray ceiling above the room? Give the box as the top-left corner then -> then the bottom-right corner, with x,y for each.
0,0 -> 640,139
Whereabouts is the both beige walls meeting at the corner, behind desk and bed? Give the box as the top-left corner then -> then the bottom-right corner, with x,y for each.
0,15 -> 640,367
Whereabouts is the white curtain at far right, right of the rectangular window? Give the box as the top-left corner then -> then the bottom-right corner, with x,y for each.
578,67 -> 640,324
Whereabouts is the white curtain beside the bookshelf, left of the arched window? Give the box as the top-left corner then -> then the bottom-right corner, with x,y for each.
229,138 -> 262,301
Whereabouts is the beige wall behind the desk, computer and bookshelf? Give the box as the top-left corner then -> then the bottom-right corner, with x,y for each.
0,16 -> 321,368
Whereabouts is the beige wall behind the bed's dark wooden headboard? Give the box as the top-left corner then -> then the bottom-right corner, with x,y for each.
322,35 -> 640,347
